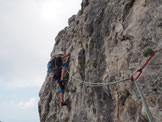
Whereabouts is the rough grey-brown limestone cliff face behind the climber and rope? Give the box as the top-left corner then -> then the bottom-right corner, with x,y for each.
38,0 -> 162,122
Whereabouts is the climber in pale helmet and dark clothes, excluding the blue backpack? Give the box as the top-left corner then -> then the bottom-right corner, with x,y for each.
49,51 -> 70,106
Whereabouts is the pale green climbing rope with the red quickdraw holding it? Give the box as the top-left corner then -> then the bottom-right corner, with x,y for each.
69,45 -> 162,122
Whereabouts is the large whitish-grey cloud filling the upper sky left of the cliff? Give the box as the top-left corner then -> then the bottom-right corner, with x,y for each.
0,0 -> 81,91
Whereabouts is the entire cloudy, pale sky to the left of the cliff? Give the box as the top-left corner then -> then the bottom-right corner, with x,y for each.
0,0 -> 82,122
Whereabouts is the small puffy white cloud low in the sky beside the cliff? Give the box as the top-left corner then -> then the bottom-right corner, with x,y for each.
17,97 -> 37,109
